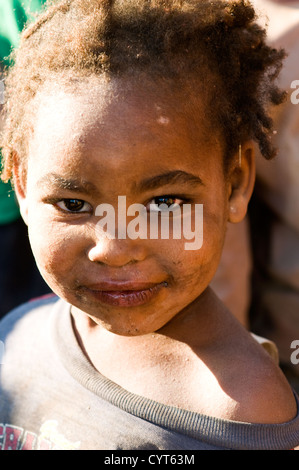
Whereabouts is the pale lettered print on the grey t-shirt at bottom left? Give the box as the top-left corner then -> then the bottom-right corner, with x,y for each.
0,420 -> 80,450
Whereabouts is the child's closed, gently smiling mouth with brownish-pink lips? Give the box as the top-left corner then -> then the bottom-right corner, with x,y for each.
82,281 -> 167,307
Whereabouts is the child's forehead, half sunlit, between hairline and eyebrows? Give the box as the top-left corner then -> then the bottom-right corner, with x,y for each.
29,79 -> 223,171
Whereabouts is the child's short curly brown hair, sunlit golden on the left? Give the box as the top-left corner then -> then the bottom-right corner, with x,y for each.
1,0 -> 285,180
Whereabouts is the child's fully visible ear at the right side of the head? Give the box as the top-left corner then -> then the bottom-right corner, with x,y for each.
228,141 -> 255,224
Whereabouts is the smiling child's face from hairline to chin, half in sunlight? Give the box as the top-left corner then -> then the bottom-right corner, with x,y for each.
17,81 -> 253,335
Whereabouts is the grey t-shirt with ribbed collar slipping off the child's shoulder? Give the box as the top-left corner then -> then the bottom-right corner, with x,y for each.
0,296 -> 299,451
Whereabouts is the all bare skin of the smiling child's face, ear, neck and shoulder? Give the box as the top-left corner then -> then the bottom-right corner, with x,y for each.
14,76 -> 296,423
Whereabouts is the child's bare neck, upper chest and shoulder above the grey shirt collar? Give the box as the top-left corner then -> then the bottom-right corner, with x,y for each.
74,284 -> 296,423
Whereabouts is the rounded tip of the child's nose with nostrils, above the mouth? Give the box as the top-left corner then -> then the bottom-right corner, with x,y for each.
88,238 -> 147,267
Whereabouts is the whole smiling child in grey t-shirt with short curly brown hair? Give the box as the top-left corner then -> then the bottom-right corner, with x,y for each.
0,0 -> 299,450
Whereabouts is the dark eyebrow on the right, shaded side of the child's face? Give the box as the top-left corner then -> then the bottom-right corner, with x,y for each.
137,170 -> 204,191
